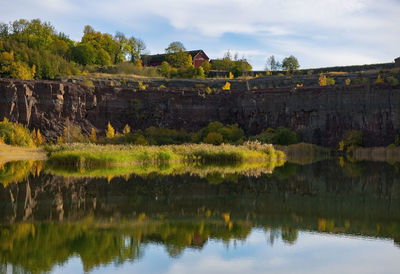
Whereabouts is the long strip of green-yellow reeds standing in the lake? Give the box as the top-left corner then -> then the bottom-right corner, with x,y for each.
46,143 -> 285,168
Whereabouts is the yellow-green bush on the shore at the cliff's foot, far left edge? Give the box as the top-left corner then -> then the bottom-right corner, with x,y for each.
0,118 -> 34,147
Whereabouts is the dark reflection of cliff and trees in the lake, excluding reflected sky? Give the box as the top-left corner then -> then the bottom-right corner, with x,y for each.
0,160 -> 400,272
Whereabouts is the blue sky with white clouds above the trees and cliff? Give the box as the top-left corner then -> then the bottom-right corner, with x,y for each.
0,0 -> 400,70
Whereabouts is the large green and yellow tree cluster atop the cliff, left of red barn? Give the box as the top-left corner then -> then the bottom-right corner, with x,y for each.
0,19 -> 147,80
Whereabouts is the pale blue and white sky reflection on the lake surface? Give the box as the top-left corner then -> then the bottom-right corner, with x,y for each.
53,229 -> 400,274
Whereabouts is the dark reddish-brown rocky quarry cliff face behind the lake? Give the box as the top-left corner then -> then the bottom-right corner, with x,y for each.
0,80 -> 400,146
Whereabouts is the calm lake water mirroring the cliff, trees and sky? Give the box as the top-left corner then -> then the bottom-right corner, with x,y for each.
0,159 -> 400,274
